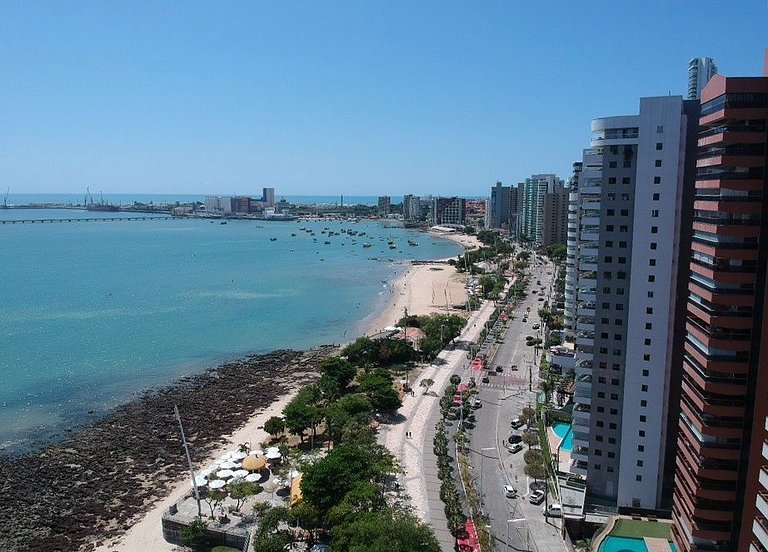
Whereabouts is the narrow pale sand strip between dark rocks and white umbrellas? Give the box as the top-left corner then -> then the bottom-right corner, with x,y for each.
96,389 -> 298,552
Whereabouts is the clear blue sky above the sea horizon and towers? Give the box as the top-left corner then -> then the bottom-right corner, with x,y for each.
0,0 -> 768,196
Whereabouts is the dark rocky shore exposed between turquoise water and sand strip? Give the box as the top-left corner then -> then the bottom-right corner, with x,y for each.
0,347 -> 336,552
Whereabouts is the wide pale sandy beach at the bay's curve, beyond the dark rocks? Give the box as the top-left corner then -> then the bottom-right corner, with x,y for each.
365,232 -> 481,335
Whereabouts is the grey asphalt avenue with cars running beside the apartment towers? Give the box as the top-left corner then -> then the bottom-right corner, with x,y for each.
460,261 -> 566,552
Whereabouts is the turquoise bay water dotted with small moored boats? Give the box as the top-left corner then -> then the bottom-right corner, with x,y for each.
0,210 -> 461,452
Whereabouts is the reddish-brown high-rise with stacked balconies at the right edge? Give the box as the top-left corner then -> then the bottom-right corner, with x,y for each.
673,72 -> 768,552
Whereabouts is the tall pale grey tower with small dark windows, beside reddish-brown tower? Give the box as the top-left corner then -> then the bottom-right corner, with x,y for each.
566,96 -> 698,509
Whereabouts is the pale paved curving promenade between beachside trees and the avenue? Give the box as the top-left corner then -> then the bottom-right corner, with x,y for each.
379,301 -> 495,551
